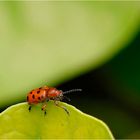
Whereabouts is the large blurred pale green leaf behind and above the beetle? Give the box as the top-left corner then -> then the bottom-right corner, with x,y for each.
0,1 -> 140,106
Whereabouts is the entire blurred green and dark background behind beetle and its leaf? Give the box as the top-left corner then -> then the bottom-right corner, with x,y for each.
0,1 -> 140,138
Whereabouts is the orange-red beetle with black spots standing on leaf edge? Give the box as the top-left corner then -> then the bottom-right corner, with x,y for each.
27,86 -> 81,115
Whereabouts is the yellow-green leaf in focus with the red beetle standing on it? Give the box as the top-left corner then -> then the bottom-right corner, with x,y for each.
0,101 -> 113,139
